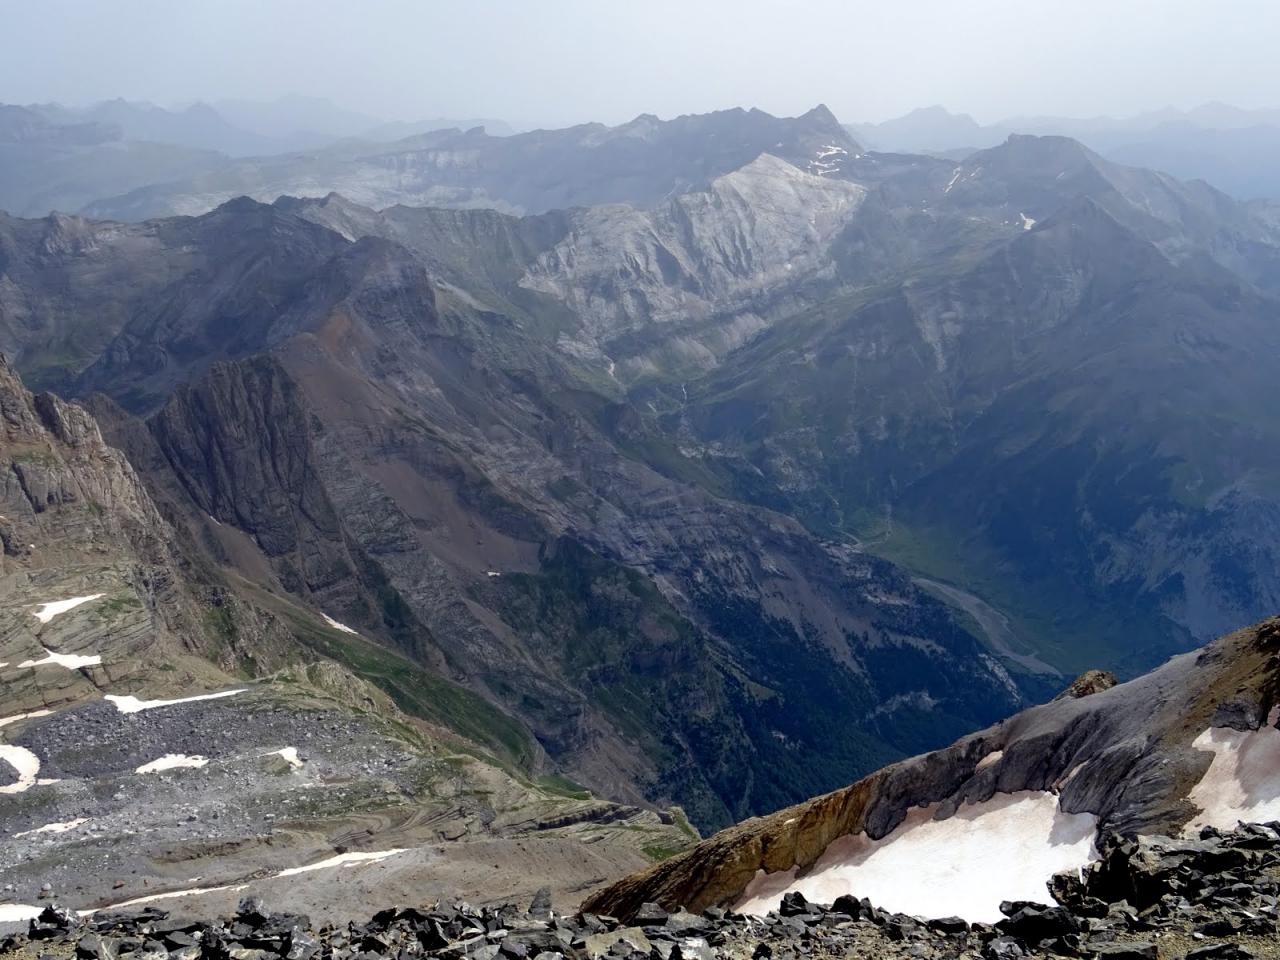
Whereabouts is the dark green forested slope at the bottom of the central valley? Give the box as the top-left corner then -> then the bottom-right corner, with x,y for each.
483,539 -> 936,837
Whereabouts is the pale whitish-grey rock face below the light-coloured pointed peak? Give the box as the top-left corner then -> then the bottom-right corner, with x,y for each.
520,154 -> 865,379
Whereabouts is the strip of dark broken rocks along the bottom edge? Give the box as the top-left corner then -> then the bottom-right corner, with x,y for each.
0,823 -> 1280,960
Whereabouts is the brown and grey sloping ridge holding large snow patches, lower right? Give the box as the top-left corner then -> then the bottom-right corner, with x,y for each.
584,620 -> 1280,919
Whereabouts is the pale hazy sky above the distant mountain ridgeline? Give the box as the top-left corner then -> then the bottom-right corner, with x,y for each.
0,0 -> 1280,124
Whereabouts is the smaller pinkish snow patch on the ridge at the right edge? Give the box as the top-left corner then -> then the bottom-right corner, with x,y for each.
1187,726 -> 1280,836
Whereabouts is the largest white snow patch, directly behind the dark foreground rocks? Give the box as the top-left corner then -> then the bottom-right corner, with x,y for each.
733,790 -> 1097,923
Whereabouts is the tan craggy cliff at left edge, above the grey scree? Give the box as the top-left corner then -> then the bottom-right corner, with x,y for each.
0,358 -> 216,713
